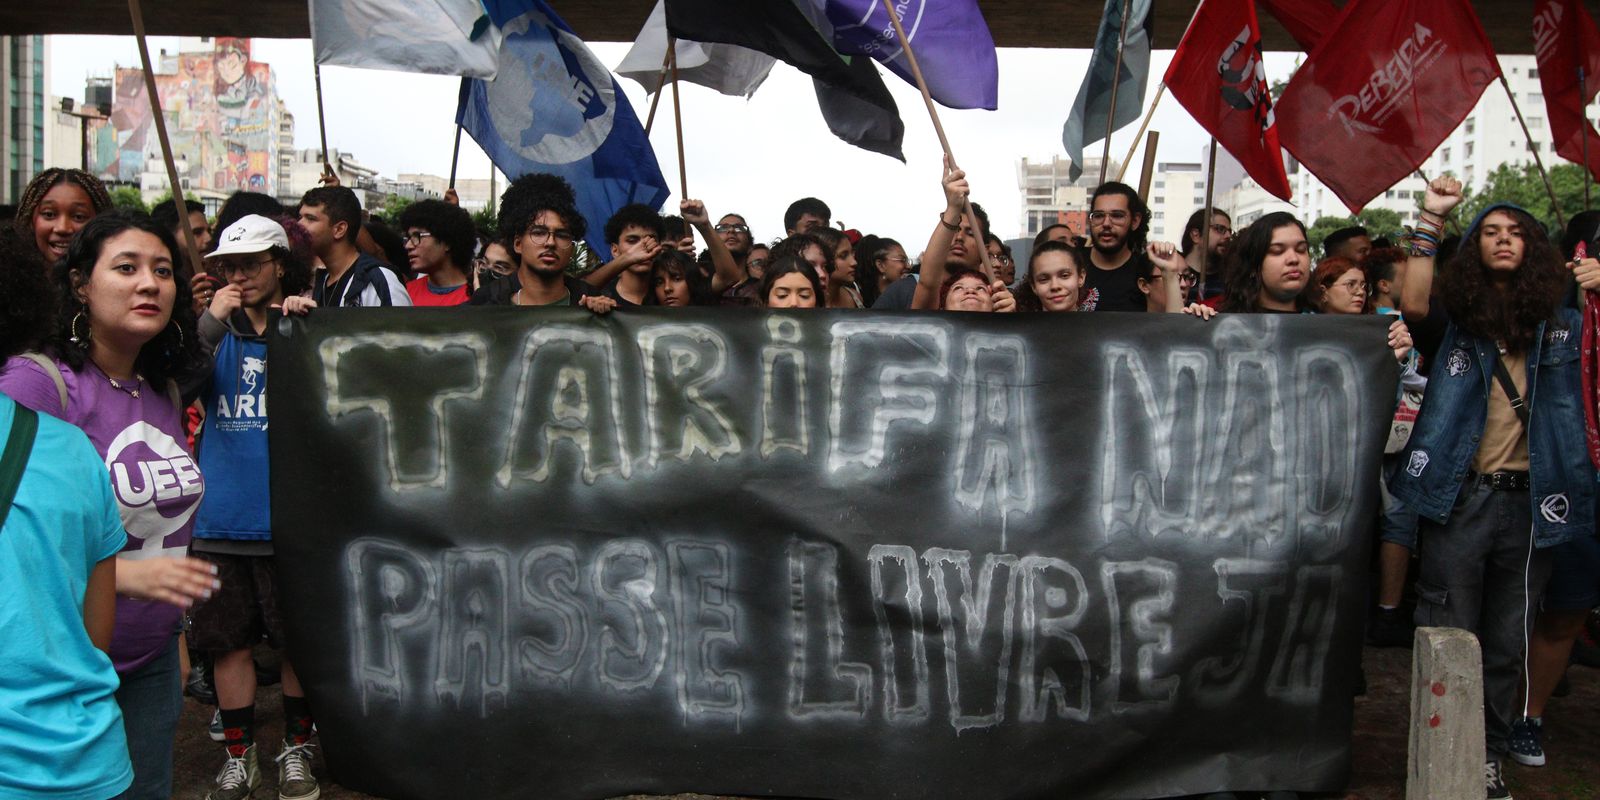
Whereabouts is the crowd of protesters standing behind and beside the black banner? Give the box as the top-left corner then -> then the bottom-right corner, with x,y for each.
0,162 -> 1600,800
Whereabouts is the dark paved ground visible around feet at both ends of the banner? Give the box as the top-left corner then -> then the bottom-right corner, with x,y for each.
174,648 -> 1600,800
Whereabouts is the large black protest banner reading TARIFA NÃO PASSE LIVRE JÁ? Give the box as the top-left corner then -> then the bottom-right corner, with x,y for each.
269,309 -> 1397,798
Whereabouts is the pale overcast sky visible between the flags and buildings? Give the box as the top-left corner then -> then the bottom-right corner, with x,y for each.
48,35 -> 1296,251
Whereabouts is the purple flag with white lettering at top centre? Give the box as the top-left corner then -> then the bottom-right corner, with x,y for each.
813,0 -> 1000,110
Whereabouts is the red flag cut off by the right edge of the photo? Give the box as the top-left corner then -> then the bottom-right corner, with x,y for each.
1533,0 -> 1600,178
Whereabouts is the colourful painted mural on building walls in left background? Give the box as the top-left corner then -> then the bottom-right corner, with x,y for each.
96,37 -> 280,194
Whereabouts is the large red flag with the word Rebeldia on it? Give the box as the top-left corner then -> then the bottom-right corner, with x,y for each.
1278,0 -> 1501,211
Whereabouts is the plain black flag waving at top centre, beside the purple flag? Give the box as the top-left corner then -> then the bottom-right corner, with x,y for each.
666,0 -> 906,162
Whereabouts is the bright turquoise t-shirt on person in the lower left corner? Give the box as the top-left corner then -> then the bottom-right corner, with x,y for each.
0,394 -> 133,800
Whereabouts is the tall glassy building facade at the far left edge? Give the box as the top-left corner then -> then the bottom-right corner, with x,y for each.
0,35 -> 51,203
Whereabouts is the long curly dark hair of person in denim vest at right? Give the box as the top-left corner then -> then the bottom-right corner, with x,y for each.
1440,205 -> 1566,352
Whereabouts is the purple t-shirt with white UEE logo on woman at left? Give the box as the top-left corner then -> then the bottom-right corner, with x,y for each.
0,357 -> 205,672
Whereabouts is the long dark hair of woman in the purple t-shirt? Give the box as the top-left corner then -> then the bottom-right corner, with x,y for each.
46,211 -> 202,392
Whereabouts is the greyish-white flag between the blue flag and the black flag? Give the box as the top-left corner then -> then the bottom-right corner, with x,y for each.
616,0 -> 776,98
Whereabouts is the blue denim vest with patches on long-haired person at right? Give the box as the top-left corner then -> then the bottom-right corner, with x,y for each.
1389,309 -> 1597,547
